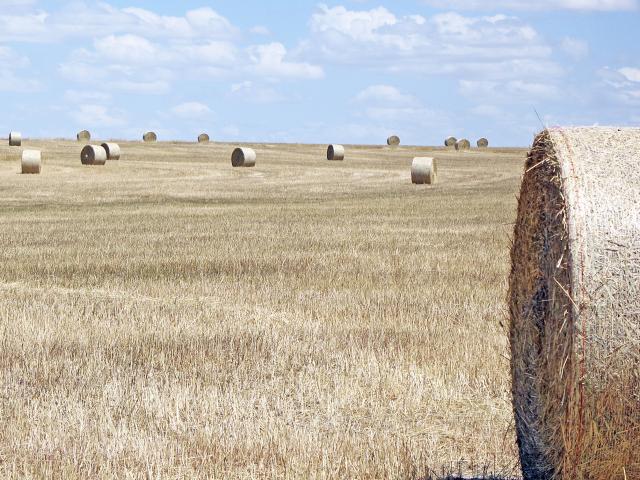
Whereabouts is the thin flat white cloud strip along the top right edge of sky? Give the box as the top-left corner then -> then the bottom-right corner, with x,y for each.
424,0 -> 638,11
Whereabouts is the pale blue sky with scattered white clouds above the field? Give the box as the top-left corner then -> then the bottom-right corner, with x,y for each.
0,0 -> 640,146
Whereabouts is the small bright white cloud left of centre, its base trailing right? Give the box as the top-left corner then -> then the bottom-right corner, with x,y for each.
248,42 -> 324,79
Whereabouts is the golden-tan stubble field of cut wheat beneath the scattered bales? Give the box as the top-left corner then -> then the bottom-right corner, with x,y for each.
0,141 -> 525,479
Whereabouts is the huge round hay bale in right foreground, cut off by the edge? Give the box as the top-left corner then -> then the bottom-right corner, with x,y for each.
508,127 -> 640,480
